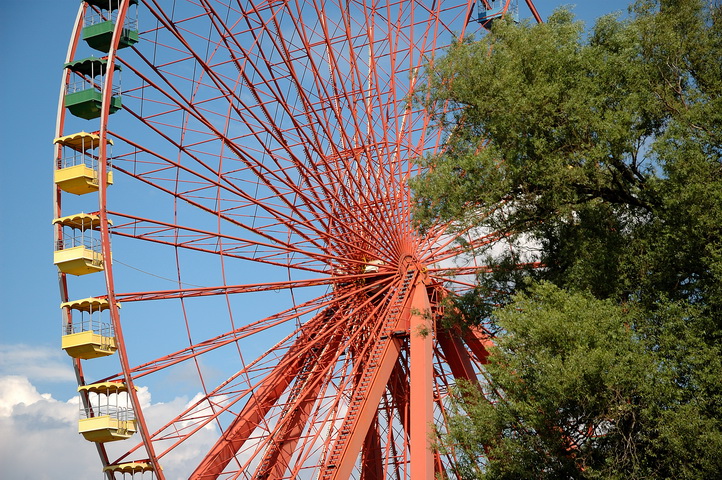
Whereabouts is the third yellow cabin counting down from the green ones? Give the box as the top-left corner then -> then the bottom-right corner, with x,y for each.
60,298 -> 118,360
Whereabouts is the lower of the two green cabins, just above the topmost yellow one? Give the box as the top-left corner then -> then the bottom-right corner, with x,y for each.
64,57 -> 123,120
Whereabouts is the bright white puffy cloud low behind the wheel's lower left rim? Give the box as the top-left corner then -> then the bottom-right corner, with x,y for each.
0,375 -> 218,480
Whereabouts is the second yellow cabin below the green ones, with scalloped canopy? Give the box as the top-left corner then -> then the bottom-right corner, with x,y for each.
53,213 -> 104,275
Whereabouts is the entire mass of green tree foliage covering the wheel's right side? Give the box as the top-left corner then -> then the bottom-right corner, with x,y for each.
412,0 -> 722,479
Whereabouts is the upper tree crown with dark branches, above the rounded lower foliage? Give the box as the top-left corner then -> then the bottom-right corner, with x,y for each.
412,0 -> 722,312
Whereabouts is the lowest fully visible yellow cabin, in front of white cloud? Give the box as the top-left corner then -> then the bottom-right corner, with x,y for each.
78,382 -> 136,443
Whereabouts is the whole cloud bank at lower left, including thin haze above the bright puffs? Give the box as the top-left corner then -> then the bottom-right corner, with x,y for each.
0,344 -> 218,480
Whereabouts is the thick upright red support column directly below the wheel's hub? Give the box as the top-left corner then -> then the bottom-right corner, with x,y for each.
409,281 -> 434,480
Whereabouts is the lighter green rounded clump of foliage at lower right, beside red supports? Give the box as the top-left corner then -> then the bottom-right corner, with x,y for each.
444,283 -> 653,479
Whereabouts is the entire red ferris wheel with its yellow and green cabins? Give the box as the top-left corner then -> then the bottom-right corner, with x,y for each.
53,0 -> 539,480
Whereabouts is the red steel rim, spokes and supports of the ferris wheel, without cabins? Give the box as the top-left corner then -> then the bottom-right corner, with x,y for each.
55,0 -> 540,480
